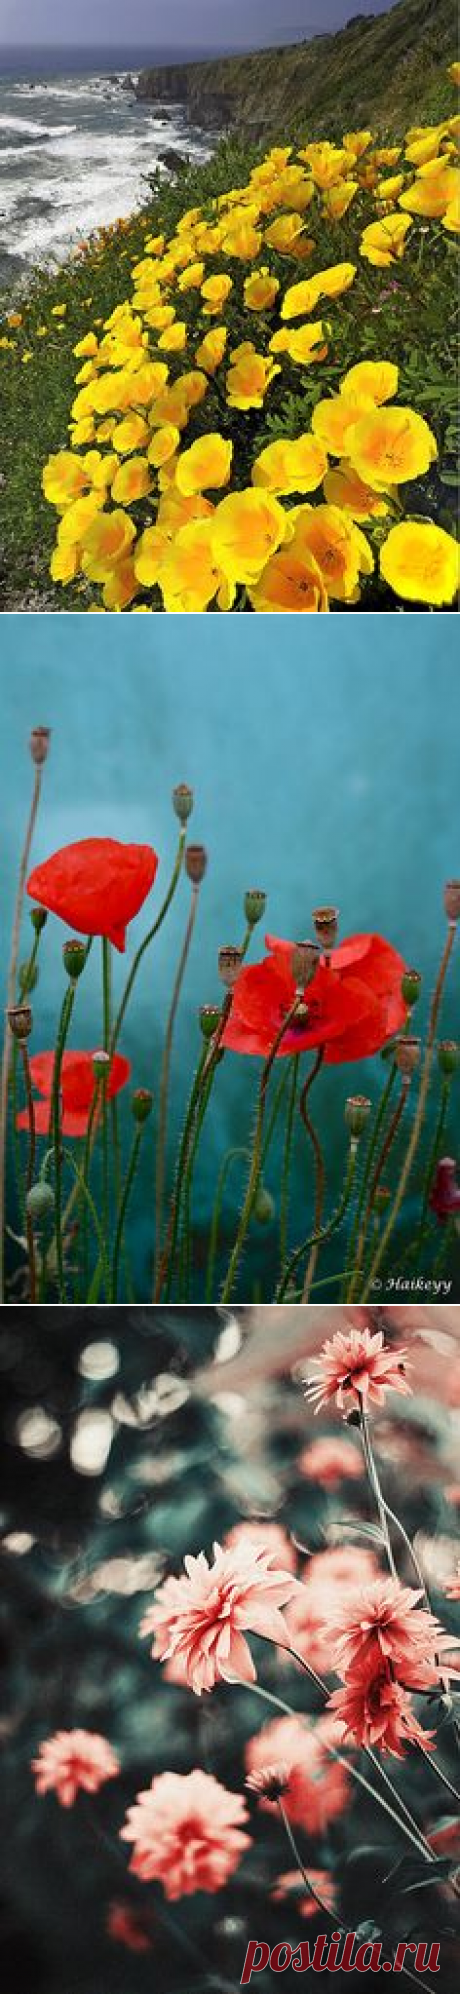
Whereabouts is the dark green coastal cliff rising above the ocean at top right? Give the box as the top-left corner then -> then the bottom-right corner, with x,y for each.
137,0 -> 456,138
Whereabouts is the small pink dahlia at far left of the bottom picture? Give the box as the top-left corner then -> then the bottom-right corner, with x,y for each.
32,1731 -> 119,1807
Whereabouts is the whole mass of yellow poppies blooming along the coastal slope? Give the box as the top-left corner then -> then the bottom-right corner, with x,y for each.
44,79 -> 460,612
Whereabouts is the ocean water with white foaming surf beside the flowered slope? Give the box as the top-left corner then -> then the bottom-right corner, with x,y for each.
0,50 -> 213,285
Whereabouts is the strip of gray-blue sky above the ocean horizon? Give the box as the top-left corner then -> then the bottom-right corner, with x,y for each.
0,0 -> 392,50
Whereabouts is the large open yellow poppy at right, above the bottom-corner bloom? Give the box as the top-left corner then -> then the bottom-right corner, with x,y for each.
343,397 -> 438,491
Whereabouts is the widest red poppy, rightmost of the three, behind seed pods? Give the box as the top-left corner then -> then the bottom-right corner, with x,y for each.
223,935 -> 406,1065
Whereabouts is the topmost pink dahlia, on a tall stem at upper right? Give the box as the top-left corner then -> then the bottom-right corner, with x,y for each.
305,1326 -> 410,1412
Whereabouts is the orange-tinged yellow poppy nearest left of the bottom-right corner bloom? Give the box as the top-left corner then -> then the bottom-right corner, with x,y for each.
291,504 -> 374,602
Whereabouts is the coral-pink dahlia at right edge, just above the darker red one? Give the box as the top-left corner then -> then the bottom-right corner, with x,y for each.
329,1579 -> 458,1689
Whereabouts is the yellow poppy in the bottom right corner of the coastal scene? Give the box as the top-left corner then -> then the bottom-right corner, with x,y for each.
380,518 -> 460,608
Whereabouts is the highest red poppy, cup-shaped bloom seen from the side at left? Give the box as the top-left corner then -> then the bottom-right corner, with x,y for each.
28,837 -> 157,953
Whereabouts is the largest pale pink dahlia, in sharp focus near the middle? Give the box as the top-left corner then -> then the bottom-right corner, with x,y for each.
139,1543 -> 297,1697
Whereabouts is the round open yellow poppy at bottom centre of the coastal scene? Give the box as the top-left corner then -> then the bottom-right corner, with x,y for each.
211,491 -> 287,584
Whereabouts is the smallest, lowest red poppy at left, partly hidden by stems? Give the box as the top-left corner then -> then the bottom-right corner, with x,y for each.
16,1053 -> 131,1135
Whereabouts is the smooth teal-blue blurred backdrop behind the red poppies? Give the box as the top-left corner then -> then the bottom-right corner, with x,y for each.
0,616 -> 458,1300
